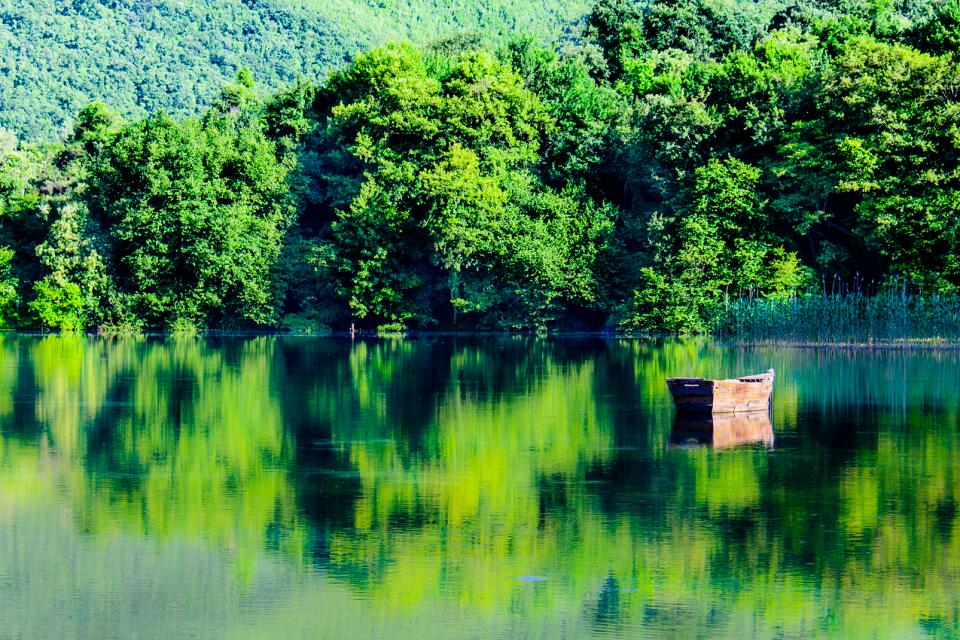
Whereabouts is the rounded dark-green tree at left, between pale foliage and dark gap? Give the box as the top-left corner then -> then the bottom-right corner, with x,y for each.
89,100 -> 293,327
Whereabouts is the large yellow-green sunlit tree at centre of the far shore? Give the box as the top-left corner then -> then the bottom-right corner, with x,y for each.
308,47 -> 612,328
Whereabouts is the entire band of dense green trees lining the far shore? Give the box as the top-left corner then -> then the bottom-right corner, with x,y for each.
0,0 -> 960,333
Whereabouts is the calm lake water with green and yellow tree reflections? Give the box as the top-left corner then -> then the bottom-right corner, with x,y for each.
0,337 -> 960,640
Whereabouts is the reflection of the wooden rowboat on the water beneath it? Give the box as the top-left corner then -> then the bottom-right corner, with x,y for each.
670,411 -> 773,449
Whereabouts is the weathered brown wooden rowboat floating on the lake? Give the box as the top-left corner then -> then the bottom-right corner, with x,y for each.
667,369 -> 774,413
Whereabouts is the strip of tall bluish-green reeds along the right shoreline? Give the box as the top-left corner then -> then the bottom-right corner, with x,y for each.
713,279 -> 960,344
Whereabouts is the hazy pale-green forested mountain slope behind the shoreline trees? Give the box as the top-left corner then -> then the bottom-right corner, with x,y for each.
0,0 -> 589,139
